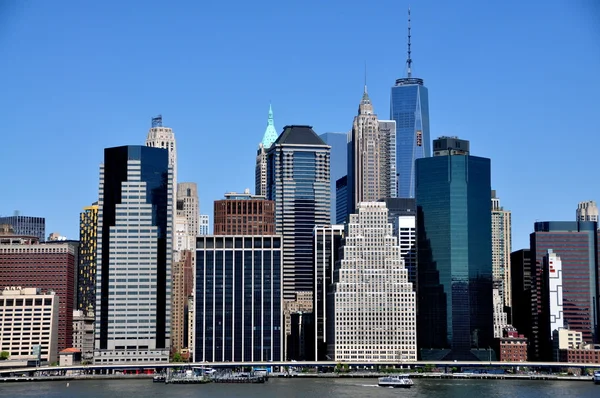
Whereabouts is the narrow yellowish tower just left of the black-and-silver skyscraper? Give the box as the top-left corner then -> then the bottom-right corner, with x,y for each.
77,202 -> 98,311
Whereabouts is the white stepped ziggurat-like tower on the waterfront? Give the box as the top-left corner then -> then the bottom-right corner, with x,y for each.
328,202 -> 417,361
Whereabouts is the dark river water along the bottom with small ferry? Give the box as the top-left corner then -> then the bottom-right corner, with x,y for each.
0,378 -> 600,398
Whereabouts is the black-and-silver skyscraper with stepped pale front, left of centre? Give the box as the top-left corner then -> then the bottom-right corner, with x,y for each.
94,146 -> 175,364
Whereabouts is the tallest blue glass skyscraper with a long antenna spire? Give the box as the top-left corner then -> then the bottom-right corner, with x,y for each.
390,9 -> 431,198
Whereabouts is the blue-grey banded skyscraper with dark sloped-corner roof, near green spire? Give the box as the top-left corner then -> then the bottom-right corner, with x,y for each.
267,126 -> 331,302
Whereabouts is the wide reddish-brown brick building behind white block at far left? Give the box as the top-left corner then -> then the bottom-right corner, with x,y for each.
0,235 -> 77,351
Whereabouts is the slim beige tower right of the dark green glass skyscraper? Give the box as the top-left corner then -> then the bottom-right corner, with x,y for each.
492,190 -> 512,307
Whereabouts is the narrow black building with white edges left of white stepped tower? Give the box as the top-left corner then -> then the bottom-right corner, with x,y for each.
310,225 -> 344,361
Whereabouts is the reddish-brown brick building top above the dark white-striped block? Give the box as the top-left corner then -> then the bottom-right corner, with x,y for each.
213,189 -> 275,235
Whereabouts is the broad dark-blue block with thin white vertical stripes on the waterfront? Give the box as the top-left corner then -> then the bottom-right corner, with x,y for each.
194,236 -> 283,362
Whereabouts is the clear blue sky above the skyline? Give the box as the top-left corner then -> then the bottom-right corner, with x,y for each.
0,0 -> 600,249
